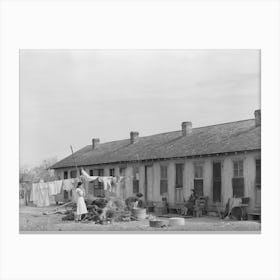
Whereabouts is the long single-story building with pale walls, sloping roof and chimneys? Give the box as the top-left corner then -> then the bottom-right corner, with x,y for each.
51,110 -> 261,211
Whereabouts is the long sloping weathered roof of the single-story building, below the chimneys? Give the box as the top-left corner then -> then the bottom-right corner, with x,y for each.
51,119 -> 261,169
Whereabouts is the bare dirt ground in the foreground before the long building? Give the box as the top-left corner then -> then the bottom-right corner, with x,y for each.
19,206 -> 261,233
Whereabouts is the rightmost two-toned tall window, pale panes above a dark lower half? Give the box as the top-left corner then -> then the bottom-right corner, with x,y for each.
232,160 -> 244,197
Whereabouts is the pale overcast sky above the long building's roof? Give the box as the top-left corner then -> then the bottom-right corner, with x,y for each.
20,50 -> 260,167
